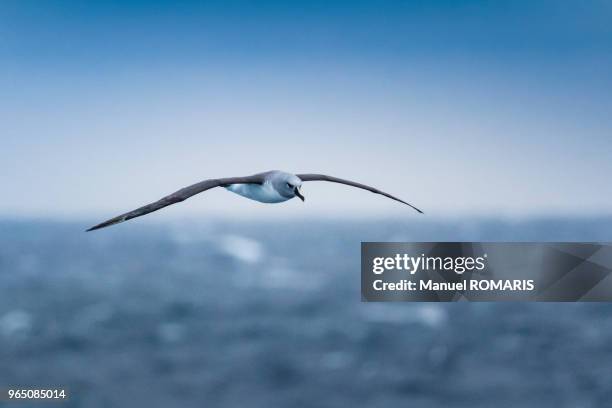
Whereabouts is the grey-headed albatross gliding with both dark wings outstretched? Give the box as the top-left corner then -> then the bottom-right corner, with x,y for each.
87,170 -> 423,231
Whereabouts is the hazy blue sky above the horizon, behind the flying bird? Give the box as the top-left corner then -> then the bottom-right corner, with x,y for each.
0,1 -> 612,217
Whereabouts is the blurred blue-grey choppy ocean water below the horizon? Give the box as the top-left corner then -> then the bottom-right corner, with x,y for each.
0,218 -> 612,408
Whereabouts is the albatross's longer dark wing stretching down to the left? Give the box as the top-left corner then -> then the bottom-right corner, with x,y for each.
87,173 -> 266,231
